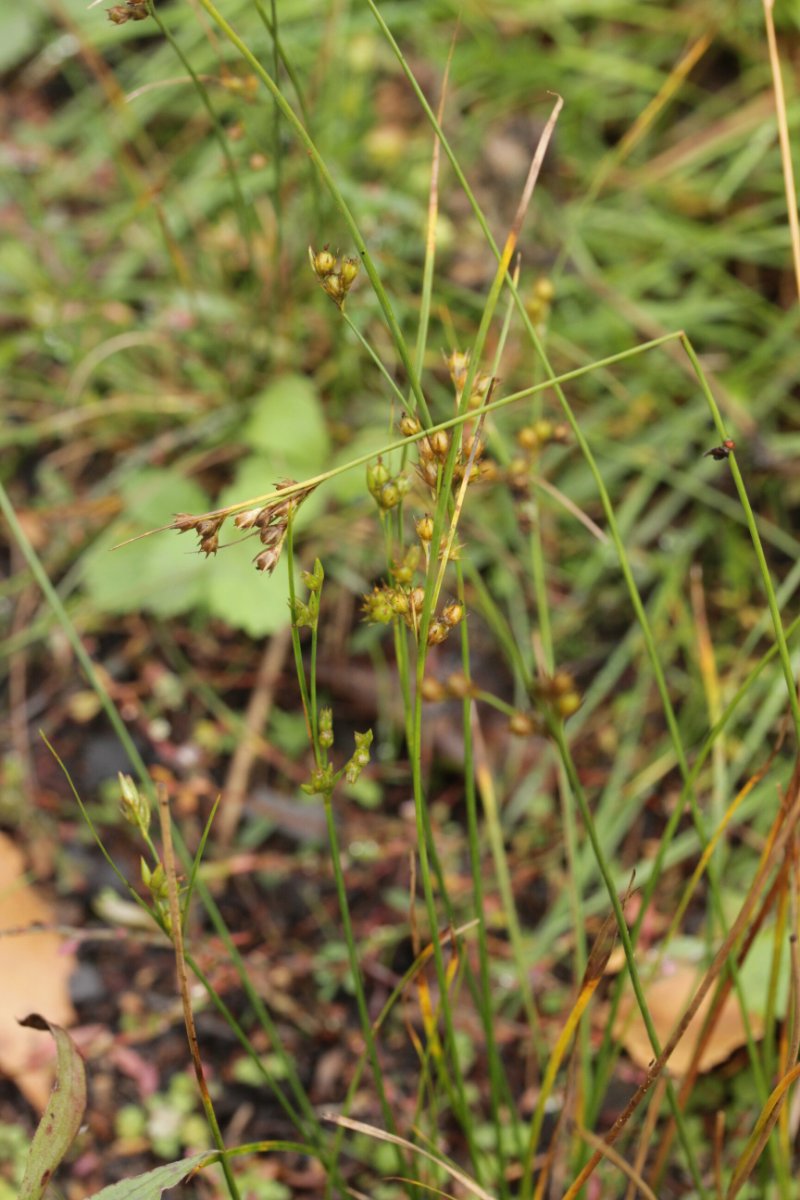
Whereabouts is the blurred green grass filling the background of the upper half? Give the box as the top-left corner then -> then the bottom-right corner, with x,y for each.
6,2 -> 800,864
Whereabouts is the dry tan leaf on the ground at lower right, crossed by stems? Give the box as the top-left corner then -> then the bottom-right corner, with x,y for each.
614,962 -> 763,1075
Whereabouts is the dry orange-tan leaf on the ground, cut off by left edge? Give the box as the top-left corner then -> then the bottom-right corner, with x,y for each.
0,834 -> 74,1110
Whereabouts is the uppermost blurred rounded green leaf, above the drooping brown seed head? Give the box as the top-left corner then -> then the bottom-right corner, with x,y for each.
242,374 -> 330,470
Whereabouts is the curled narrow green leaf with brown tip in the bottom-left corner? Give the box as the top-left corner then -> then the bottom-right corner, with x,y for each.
19,1013 -> 86,1200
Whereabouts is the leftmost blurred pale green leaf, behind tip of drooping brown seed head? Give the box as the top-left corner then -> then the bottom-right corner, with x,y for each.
83,469 -> 210,617
